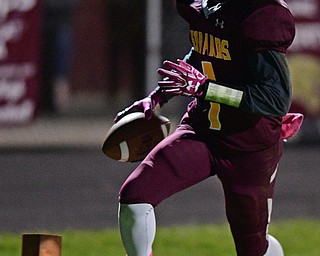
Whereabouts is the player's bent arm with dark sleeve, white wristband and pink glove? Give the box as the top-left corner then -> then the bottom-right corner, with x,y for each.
158,51 -> 291,116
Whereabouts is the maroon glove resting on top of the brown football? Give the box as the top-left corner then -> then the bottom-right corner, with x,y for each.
113,91 -> 164,122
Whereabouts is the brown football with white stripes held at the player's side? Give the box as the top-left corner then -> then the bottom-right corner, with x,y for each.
102,112 -> 170,162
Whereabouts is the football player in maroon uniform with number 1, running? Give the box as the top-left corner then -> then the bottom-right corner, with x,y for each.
115,0 -> 302,256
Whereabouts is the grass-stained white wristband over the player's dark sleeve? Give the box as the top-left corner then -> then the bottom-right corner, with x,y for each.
204,82 -> 243,108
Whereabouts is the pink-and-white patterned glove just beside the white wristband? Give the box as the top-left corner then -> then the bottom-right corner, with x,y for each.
158,60 -> 208,97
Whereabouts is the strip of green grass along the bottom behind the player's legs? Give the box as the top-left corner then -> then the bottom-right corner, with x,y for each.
0,220 -> 320,256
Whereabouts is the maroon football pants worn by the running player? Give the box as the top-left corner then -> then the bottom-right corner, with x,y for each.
119,125 -> 281,256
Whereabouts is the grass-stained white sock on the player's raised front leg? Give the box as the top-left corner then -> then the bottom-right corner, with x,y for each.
118,204 -> 156,256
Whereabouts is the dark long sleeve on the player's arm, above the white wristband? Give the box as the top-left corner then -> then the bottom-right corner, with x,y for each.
239,51 -> 291,116
